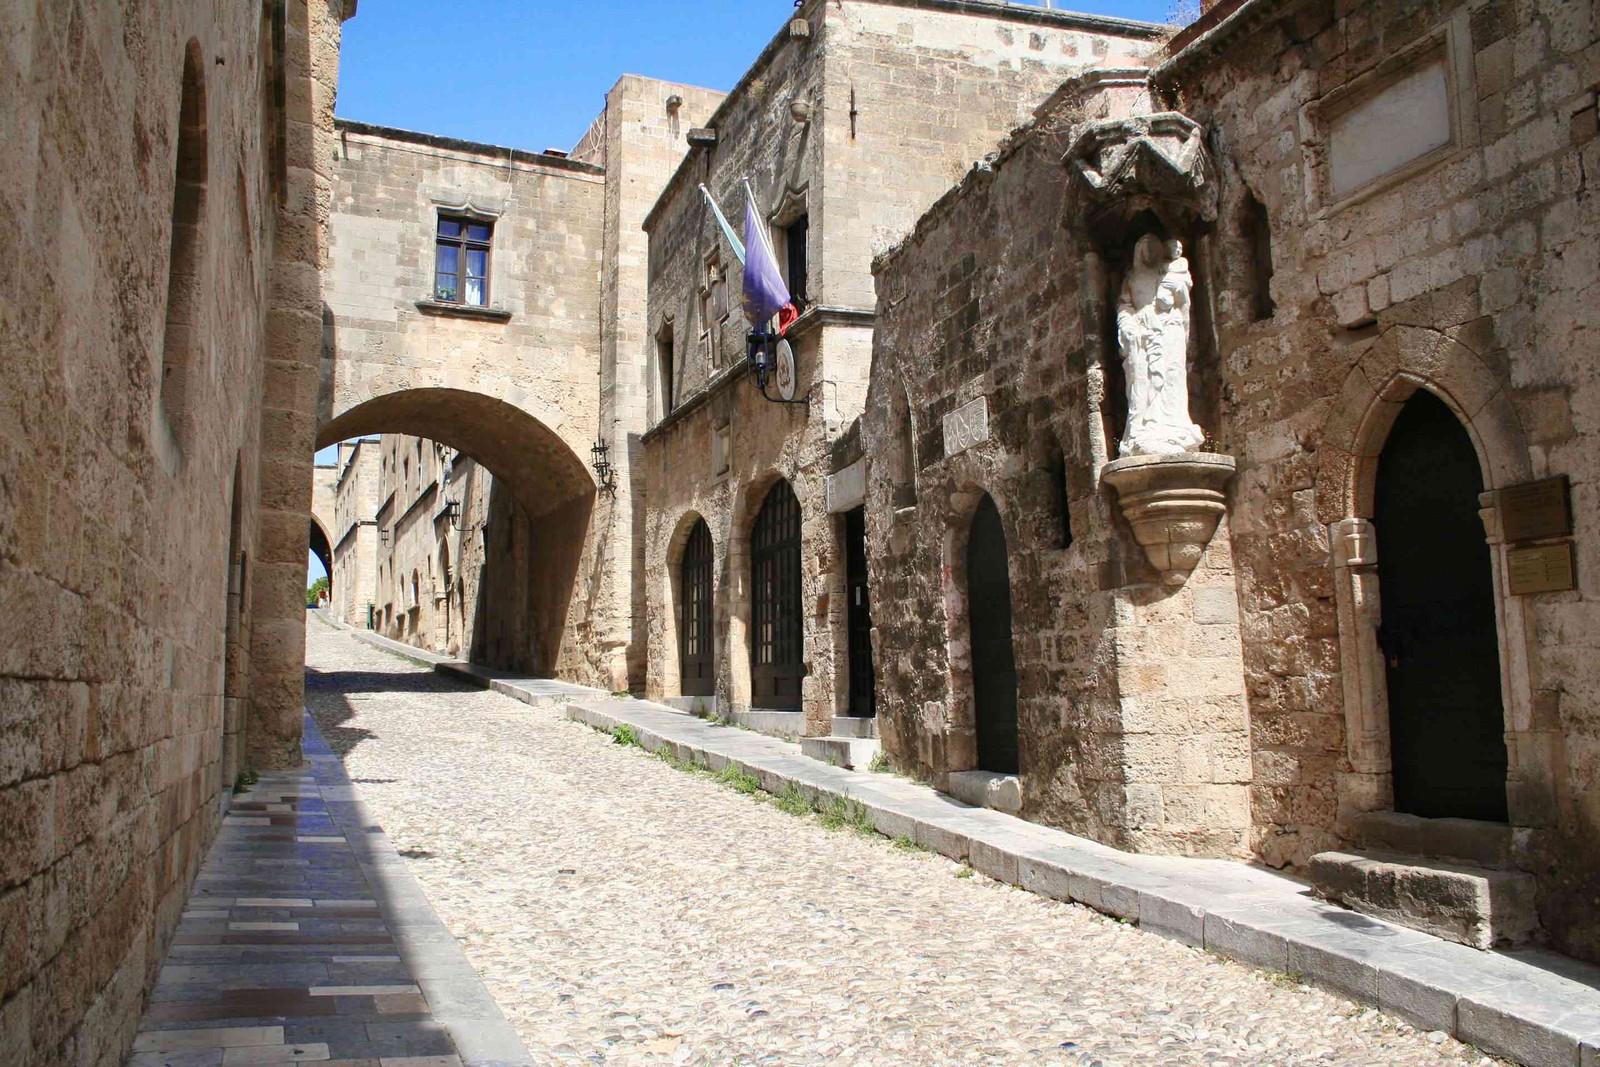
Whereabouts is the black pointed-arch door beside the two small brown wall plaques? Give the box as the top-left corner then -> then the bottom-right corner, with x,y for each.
1373,389 -> 1506,822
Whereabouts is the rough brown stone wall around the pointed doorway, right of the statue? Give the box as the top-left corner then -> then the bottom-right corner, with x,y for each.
1162,0 -> 1600,957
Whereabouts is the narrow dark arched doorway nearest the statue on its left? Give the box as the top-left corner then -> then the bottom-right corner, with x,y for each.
966,494 -> 1019,774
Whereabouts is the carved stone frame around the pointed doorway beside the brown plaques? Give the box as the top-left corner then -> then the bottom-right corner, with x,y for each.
1317,326 -> 1560,841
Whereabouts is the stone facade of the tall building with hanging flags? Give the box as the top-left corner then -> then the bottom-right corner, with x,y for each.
630,0 -> 1158,734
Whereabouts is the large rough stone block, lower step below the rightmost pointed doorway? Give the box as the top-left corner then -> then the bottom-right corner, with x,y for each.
1309,851 -> 1539,949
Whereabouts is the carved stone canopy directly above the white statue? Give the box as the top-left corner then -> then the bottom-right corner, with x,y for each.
1061,112 -> 1218,230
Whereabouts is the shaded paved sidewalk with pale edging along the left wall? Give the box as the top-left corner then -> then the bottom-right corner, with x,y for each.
128,717 -> 533,1067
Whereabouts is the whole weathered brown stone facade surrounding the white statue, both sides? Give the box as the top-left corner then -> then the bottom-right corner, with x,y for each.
861,0 -> 1600,958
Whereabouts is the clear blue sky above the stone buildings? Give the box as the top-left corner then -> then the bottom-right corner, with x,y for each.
338,0 -> 1173,150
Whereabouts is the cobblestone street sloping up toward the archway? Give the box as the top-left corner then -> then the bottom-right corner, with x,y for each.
307,621 -> 1490,1067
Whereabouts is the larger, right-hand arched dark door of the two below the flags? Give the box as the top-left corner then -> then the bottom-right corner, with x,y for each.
750,482 -> 803,712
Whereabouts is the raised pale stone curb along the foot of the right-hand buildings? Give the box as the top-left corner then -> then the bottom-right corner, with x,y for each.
531,700 -> 1600,1067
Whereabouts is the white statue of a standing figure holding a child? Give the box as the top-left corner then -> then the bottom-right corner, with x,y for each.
1117,234 -> 1205,456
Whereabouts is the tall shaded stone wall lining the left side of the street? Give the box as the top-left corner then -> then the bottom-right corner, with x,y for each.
0,0 -> 355,1065
